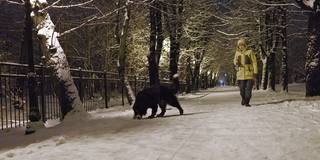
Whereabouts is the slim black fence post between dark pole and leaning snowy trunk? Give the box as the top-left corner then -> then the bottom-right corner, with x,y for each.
40,56 -> 47,122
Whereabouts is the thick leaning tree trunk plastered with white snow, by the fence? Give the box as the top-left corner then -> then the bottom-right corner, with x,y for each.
31,0 -> 86,119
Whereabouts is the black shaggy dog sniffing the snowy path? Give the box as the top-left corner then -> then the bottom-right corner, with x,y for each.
132,86 -> 183,119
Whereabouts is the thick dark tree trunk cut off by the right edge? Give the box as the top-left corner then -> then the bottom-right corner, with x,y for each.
305,12 -> 320,97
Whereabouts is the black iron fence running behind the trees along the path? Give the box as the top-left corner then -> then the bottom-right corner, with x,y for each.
0,62 -> 186,130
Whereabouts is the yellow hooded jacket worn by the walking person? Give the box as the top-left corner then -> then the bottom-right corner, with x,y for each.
233,50 -> 258,80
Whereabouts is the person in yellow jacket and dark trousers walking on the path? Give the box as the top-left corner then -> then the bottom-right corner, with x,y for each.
233,38 -> 258,107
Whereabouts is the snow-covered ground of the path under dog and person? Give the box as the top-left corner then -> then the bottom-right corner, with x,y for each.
0,84 -> 320,160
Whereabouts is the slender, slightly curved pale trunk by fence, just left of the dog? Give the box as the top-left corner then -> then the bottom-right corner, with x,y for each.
118,0 -> 135,105
